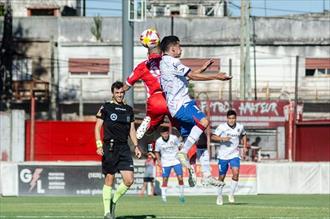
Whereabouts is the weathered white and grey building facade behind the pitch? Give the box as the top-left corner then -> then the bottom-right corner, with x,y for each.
0,14 -> 330,118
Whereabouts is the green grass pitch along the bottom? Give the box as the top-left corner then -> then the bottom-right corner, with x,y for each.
0,195 -> 330,219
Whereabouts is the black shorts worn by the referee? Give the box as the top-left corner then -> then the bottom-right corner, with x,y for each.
102,144 -> 134,175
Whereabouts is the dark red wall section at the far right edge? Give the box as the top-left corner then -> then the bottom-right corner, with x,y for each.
296,120 -> 330,161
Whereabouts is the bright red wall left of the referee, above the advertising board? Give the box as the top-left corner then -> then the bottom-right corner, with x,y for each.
25,121 -> 101,161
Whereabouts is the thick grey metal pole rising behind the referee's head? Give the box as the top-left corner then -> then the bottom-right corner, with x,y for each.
122,0 -> 134,107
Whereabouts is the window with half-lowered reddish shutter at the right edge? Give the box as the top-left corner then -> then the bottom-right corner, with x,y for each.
305,58 -> 330,77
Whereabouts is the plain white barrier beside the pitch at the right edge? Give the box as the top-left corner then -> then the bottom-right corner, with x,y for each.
257,162 -> 330,194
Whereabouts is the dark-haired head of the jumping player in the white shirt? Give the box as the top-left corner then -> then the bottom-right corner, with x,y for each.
160,35 -> 182,58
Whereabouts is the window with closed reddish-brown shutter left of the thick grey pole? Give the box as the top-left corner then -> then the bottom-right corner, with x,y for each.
69,58 -> 110,75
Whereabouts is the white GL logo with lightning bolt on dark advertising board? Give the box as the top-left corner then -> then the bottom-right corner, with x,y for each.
19,168 -> 45,194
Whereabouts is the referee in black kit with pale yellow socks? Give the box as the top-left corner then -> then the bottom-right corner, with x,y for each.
95,81 -> 141,219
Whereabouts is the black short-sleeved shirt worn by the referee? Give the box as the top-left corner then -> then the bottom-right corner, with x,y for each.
96,101 -> 134,143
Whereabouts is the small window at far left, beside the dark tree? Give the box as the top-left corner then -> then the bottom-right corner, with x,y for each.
12,59 -> 32,81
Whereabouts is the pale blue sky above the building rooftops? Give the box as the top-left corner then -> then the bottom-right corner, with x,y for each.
86,0 -> 330,16
